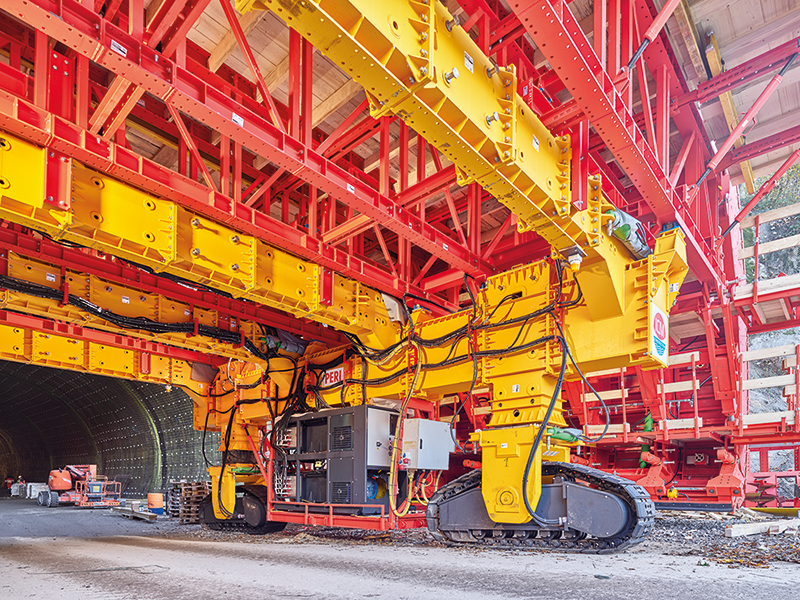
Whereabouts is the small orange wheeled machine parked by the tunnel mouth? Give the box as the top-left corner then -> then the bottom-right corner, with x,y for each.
38,465 -> 121,508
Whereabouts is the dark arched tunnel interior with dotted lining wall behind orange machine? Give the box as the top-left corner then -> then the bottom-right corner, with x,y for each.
0,361 -> 218,496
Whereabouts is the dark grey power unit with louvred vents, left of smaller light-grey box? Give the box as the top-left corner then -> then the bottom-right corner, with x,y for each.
275,405 -> 405,514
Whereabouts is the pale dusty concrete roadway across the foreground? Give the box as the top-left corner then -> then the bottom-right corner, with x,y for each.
0,499 -> 800,600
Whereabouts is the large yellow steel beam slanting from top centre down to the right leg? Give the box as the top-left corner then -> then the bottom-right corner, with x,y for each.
237,0 -> 600,264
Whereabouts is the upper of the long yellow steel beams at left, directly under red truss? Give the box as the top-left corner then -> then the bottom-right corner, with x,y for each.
0,134 -> 400,347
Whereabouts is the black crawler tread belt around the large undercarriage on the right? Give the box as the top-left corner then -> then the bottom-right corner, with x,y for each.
427,462 -> 656,554
